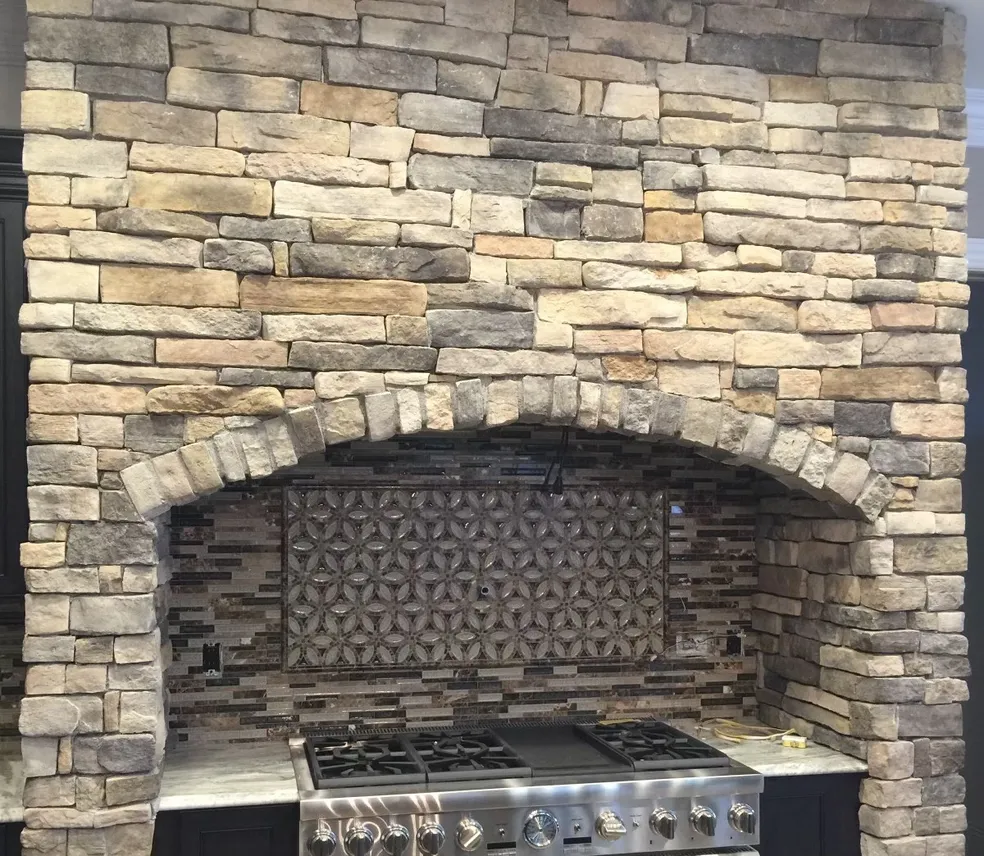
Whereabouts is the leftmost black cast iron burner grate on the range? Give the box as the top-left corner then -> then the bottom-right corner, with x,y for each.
304,736 -> 427,788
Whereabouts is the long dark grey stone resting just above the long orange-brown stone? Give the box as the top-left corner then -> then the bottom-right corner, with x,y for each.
290,244 -> 469,282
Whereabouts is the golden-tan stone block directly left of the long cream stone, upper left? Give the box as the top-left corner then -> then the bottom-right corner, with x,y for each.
130,172 -> 273,217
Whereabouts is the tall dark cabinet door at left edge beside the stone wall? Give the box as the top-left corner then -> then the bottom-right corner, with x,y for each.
0,135 -> 27,595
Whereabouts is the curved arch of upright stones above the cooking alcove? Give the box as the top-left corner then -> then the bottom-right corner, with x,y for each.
121,376 -> 894,521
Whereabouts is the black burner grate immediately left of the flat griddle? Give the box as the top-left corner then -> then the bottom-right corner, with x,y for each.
407,731 -> 532,782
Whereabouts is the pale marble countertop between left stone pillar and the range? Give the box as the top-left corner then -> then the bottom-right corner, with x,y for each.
160,740 -> 297,811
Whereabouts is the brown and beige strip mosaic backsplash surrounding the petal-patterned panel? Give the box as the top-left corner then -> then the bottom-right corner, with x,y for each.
169,426 -> 757,742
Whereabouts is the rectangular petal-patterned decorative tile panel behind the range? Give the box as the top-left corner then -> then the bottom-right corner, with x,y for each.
284,486 -> 666,670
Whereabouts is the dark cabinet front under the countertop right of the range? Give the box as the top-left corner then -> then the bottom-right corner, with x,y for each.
759,774 -> 862,856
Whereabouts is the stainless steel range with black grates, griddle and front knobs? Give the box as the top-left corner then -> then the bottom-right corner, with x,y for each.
291,720 -> 763,856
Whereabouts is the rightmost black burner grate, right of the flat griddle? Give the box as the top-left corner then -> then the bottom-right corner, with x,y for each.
580,719 -> 731,770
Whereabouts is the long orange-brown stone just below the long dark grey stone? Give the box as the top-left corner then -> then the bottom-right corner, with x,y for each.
240,276 -> 427,316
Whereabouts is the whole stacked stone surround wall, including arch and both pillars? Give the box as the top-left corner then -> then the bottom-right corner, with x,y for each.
13,0 -> 968,856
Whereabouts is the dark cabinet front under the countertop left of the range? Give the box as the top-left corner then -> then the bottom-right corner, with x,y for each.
154,805 -> 299,856
